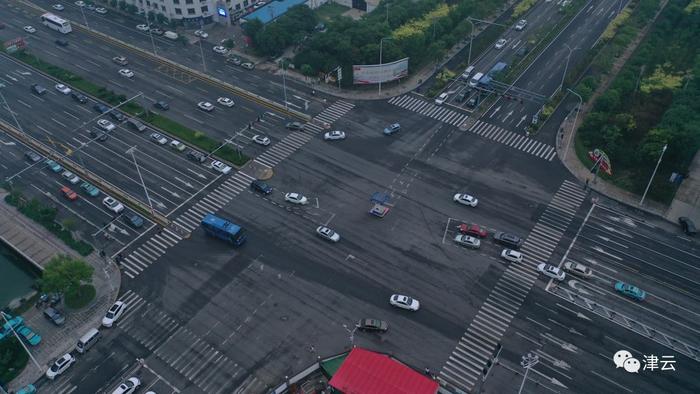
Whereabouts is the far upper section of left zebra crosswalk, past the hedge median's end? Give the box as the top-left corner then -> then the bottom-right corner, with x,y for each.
255,100 -> 355,168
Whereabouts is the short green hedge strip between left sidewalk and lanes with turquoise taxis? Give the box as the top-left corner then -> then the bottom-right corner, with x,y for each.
5,190 -> 94,256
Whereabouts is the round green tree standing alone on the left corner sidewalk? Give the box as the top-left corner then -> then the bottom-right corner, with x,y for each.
40,255 -> 95,296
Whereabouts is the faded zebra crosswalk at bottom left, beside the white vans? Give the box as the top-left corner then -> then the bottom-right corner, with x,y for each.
117,290 -> 263,394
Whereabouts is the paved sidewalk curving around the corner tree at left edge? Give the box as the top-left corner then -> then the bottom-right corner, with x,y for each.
0,191 -> 121,391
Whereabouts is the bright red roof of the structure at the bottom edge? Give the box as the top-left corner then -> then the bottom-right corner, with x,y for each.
329,348 -> 438,394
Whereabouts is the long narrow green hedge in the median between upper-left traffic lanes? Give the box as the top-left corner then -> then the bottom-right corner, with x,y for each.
13,51 -> 250,167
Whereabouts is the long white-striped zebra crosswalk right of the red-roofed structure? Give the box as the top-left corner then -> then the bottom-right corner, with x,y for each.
438,181 -> 586,392
